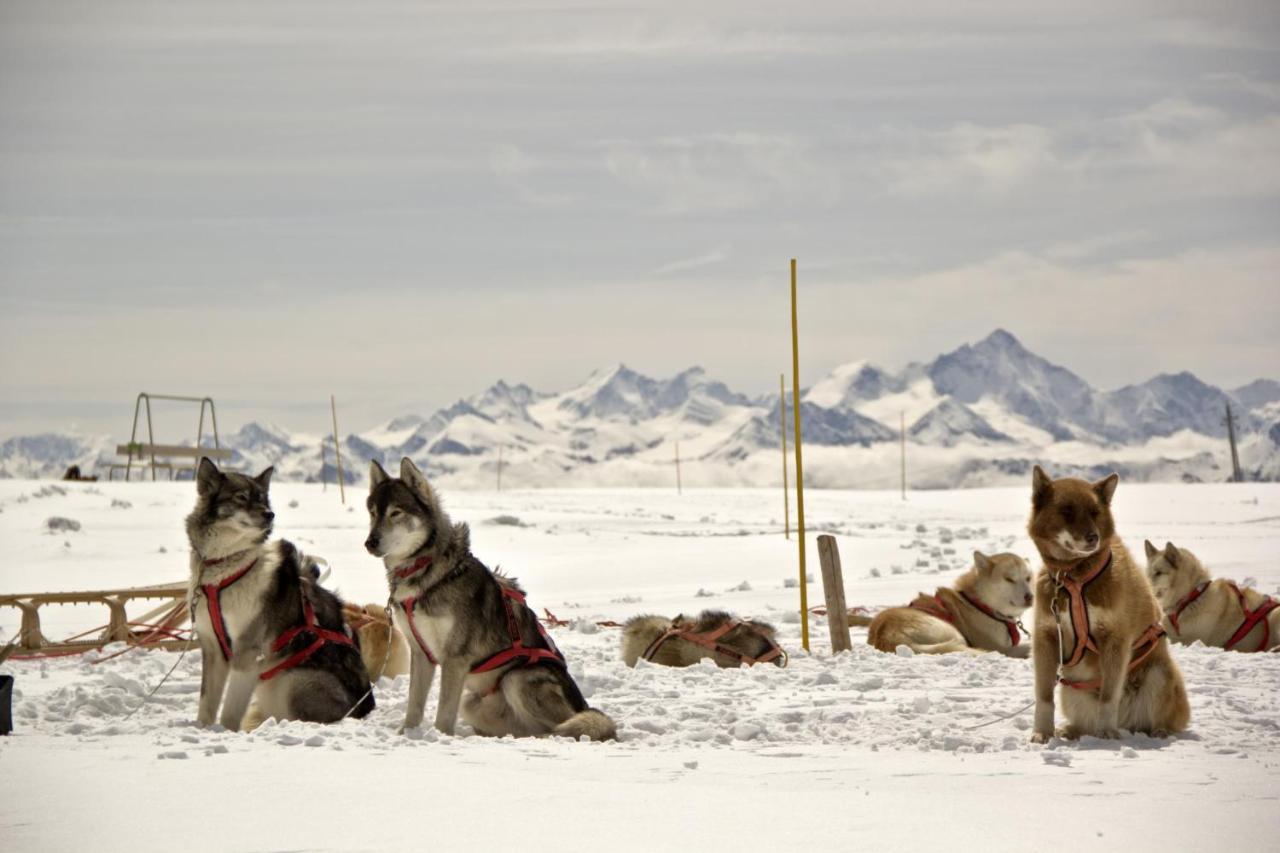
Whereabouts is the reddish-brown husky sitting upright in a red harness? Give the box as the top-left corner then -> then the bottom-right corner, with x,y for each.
1028,465 -> 1190,743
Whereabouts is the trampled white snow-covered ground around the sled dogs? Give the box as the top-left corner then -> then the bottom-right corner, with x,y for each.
0,480 -> 1280,852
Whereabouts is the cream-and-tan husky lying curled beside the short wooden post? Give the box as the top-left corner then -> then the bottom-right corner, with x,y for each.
867,551 -> 1032,657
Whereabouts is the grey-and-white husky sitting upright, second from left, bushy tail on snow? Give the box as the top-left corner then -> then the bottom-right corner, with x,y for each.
365,459 -> 617,740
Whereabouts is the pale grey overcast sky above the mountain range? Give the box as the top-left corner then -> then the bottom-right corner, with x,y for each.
0,0 -> 1280,434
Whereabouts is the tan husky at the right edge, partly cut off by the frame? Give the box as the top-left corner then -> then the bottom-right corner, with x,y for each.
1146,542 -> 1280,652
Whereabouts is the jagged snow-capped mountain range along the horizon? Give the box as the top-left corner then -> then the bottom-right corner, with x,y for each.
0,329 -> 1280,488
